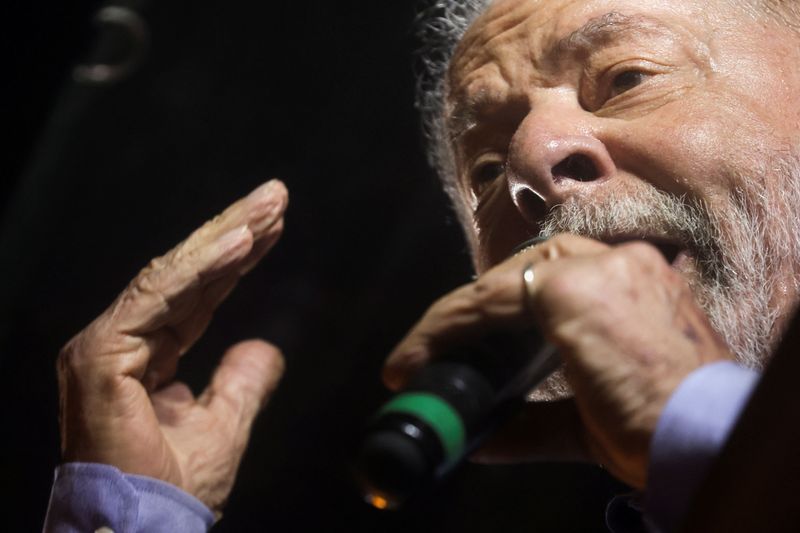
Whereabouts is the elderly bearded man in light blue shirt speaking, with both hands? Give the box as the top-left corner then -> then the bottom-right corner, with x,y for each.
40,0 -> 800,531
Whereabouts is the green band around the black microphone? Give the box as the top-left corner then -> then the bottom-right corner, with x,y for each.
379,392 -> 466,461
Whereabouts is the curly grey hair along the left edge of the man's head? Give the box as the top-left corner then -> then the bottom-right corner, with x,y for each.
416,0 -> 492,227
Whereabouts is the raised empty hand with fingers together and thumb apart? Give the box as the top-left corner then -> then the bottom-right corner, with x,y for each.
58,181 -> 287,513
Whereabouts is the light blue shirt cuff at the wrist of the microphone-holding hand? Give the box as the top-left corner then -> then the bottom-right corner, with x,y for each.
644,361 -> 759,531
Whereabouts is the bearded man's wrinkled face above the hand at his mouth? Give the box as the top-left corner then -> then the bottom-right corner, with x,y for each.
446,0 -> 800,362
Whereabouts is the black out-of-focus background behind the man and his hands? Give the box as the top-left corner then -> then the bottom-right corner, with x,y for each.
0,0 -> 621,532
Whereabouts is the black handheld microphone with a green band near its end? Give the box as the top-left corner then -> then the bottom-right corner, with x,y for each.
356,237 -> 561,509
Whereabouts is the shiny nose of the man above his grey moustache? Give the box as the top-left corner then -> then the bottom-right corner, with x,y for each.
506,101 -> 616,223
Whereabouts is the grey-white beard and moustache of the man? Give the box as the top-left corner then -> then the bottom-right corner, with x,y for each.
531,160 -> 800,400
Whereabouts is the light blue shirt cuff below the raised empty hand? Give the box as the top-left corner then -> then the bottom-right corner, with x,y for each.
44,463 -> 214,533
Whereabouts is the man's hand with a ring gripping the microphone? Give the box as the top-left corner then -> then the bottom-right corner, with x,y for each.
362,235 -> 730,503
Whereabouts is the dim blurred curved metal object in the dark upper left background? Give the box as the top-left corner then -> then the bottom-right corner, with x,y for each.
72,5 -> 150,85
